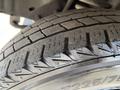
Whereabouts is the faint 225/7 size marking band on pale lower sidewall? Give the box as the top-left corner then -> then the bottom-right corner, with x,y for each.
60,75 -> 120,90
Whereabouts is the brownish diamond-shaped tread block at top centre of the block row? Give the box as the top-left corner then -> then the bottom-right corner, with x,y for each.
61,20 -> 83,29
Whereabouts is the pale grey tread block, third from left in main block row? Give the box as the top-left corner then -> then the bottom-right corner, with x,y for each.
14,38 -> 30,50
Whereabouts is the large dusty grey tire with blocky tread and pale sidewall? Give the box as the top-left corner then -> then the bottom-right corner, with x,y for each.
0,9 -> 120,90
